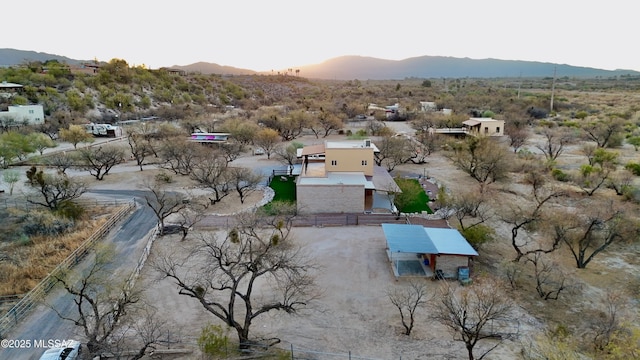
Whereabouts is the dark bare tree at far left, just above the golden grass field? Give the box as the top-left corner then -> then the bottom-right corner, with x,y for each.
27,168 -> 87,210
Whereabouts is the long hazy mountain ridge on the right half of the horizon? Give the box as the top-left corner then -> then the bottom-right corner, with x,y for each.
296,56 -> 640,80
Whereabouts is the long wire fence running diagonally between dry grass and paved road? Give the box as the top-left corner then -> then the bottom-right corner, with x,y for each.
0,201 -> 135,339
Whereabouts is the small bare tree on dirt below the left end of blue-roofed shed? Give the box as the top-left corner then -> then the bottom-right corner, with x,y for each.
387,281 -> 428,335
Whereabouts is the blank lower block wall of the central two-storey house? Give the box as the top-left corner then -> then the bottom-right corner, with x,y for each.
296,185 -> 364,214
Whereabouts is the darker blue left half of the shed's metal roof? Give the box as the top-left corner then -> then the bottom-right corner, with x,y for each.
382,224 -> 438,254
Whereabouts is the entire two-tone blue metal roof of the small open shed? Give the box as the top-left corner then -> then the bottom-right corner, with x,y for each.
382,224 -> 478,256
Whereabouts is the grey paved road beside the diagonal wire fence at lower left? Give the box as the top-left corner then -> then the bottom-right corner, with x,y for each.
0,190 -> 157,360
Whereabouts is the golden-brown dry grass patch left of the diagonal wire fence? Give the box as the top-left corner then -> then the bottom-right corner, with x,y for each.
0,212 -> 114,296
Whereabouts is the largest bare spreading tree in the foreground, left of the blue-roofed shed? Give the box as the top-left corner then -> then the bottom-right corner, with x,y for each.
154,214 -> 317,348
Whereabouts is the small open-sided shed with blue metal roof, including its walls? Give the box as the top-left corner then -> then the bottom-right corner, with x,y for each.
382,224 -> 478,279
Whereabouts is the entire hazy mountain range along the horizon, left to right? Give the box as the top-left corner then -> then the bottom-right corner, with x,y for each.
0,49 -> 640,80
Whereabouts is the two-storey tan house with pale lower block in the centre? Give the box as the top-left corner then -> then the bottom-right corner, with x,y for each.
296,140 -> 400,213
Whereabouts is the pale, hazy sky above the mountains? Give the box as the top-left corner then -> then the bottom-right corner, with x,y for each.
6,0 -> 640,71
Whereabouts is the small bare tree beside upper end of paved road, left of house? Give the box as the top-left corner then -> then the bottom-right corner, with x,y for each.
142,179 -> 188,236
